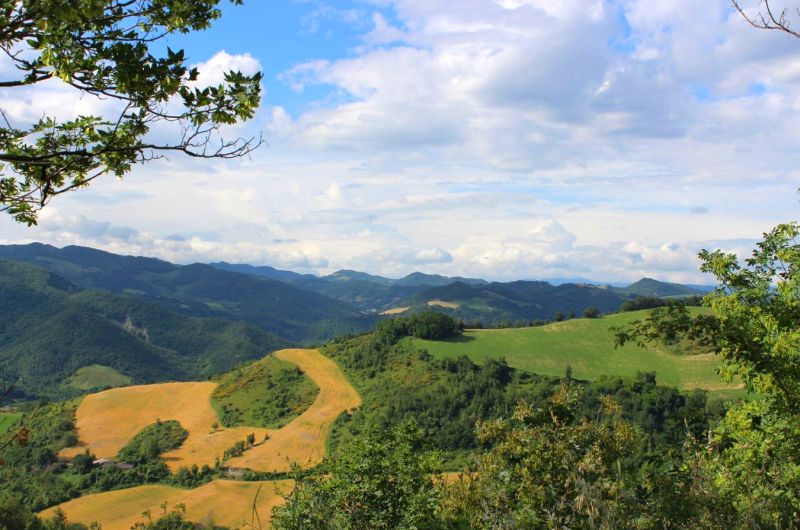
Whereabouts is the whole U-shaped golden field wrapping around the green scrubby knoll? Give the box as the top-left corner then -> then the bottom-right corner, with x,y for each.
61,349 -> 361,471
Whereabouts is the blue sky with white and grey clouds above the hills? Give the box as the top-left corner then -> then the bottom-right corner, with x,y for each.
0,0 -> 800,283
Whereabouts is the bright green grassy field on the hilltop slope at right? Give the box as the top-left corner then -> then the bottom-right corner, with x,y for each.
416,309 -> 743,398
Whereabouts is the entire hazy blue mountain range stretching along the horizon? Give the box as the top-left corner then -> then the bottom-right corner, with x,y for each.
0,243 -> 704,343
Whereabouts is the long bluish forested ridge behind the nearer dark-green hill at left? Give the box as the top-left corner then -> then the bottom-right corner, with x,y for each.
0,243 -> 374,342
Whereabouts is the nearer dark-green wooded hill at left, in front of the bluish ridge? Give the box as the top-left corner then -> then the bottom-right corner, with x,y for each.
0,260 -> 287,397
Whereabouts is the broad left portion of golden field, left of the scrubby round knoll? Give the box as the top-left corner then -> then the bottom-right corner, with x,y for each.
61,383 -> 272,471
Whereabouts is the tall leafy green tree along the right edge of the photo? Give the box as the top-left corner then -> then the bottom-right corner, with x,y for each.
619,223 -> 800,528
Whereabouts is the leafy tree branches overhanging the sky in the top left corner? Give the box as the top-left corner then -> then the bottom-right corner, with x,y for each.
0,0 -> 262,226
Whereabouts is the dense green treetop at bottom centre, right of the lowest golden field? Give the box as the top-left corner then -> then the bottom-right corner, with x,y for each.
271,422 -> 444,530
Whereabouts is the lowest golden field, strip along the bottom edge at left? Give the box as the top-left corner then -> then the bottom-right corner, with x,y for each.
41,480 -> 293,530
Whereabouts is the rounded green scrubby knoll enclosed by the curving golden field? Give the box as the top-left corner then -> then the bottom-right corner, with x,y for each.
211,355 -> 319,429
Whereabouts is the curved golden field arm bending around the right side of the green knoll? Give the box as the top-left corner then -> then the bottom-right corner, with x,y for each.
228,349 -> 361,471
